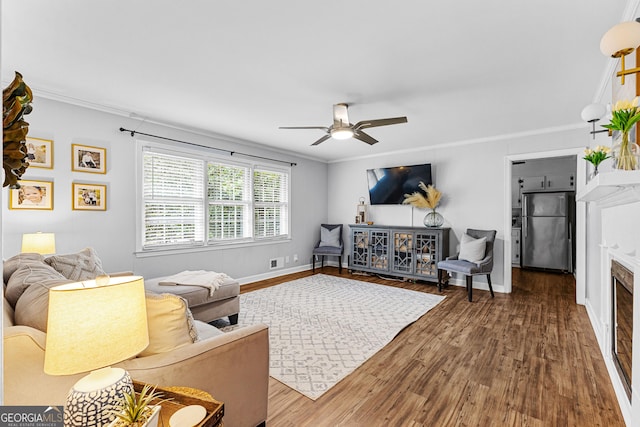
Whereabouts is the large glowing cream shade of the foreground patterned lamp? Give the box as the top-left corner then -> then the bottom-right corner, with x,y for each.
44,276 -> 149,375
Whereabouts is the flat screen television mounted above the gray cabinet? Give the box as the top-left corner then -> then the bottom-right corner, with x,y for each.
367,163 -> 433,205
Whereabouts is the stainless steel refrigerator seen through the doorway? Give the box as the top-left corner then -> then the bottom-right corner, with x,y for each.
522,191 -> 575,273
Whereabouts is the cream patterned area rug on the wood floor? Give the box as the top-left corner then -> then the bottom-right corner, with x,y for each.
230,274 -> 444,400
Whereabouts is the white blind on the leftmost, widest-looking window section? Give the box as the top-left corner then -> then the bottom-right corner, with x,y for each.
142,151 -> 205,249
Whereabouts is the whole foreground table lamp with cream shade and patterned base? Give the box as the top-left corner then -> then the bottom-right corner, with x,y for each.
44,276 -> 149,427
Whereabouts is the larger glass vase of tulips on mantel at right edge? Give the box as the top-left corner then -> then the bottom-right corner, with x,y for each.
602,97 -> 640,170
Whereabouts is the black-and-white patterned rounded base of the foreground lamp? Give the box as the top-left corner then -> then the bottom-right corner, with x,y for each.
64,368 -> 133,427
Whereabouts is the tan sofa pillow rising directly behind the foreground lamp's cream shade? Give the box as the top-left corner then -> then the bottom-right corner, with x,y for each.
12,269 -> 73,332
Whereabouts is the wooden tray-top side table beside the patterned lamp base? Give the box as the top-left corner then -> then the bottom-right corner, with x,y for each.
133,381 -> 224,427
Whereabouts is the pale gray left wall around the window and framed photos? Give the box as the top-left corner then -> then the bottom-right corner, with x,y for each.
2,98 -> 327,281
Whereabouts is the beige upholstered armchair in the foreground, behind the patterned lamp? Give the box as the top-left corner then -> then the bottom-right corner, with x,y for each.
3,299 -> 269,427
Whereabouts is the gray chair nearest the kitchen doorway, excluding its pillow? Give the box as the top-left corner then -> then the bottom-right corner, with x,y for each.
438,228 -> 496,302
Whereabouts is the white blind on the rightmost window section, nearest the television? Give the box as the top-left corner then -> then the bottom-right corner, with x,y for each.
253,169 -> 289,238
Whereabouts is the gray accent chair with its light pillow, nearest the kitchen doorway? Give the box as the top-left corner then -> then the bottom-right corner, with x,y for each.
438,228 -> 496,302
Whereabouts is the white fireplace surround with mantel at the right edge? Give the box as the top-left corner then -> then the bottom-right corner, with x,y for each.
576,171 -> 640,426
